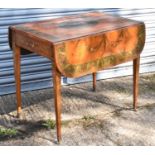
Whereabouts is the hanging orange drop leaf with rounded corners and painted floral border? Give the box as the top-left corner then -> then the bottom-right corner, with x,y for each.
55,24 -> 145,77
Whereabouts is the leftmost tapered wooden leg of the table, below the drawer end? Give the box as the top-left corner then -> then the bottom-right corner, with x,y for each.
13,44 -> 21,117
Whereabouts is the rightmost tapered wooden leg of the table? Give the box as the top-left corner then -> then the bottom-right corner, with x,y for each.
133,56 -> 140,111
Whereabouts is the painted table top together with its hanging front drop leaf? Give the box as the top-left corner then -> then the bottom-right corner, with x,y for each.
10,12 -> 145,77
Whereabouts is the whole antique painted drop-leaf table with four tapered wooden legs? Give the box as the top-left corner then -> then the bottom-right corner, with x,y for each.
9,12 -> 145,142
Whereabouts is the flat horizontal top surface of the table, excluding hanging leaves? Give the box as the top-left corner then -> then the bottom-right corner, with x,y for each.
10,12 -> 143,43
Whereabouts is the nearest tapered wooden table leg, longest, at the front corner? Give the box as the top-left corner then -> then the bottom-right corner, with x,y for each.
53,64 -> 61,143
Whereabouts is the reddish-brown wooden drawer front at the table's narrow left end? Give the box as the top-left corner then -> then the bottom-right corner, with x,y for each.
15,32 -> 53,59
